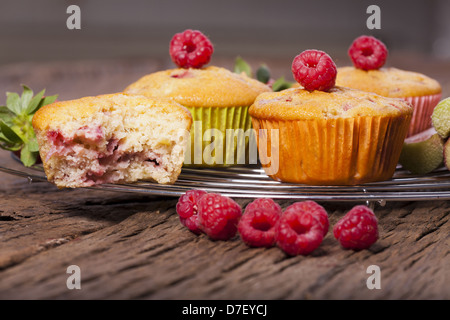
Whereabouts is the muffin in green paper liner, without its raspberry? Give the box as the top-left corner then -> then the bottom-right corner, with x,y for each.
124,66 -> 272,167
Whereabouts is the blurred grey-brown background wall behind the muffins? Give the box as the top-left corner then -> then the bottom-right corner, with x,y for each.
0,0 -> 450,64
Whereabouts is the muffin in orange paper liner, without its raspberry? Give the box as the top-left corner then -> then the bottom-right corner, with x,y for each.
249,86 -> 413,185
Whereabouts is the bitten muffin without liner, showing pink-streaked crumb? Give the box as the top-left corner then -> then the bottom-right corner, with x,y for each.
32,94 -> 192,188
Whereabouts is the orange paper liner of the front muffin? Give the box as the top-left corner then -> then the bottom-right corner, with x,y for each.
252,115 -> 411,185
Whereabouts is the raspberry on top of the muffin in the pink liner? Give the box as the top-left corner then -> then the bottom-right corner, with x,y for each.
348,36 -> 388,70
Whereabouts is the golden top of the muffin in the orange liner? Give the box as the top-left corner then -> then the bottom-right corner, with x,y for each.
249,86 -> 413,120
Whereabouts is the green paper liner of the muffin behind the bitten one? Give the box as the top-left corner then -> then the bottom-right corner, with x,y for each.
183,106 -> 258,167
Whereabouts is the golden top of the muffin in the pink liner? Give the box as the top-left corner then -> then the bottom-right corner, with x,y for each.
336,67 -> 442,98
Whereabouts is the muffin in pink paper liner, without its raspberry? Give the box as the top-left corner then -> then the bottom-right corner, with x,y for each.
336,66 -> 442,136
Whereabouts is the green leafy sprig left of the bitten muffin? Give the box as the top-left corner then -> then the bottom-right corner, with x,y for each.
0,85 -> 57,167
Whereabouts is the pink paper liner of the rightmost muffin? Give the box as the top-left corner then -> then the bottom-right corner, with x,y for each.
403,93 -> 442,137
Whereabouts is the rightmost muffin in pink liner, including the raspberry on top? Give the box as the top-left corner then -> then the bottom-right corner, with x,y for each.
336,36 -> 442,136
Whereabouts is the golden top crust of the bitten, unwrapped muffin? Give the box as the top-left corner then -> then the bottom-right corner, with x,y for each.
32,93 -> 192,130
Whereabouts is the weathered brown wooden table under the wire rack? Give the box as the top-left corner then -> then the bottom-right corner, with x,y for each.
0,57 -> 450,300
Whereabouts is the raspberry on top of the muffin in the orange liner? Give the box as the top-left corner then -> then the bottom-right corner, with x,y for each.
292,50 -> 337,91
